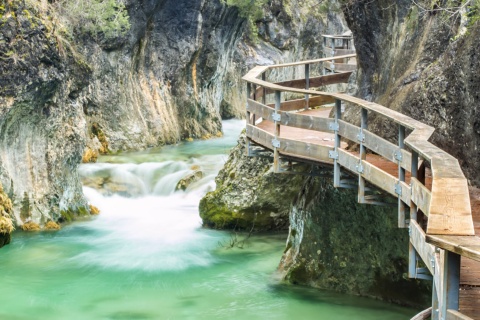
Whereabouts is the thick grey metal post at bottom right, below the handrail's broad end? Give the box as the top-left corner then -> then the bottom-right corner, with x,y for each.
439,251 -> 460,319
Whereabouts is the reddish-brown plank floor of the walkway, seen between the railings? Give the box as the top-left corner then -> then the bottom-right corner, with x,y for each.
257,107 -> 480,319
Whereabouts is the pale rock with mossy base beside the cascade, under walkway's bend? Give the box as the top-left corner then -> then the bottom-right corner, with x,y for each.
199,134 -> 308,230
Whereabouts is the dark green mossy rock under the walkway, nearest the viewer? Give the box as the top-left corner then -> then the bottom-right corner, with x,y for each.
279,177 -> 431,307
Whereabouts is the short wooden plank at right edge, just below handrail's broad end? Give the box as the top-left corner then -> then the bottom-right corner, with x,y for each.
427,234 -> 480,261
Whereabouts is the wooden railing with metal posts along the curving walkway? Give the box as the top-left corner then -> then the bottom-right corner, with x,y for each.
243,54 -> 480,319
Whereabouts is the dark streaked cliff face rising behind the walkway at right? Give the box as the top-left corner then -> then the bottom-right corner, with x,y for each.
344,0 -> 480,186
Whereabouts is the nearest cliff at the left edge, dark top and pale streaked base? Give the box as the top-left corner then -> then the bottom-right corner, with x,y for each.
0,2 -> 90,222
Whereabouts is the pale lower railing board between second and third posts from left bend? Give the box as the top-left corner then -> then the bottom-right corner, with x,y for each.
279,138 -> 333,163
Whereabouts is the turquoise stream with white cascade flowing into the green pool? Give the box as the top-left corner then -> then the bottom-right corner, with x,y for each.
0,121 -> 415,320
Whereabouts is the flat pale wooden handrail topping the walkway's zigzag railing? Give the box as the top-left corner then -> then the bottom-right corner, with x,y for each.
243,55 -> 474,236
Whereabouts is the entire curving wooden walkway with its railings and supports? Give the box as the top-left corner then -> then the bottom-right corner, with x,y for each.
243,36 -> 480,320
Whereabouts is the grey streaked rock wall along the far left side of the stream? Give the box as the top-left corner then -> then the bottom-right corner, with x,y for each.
0,0 -> 342,228
